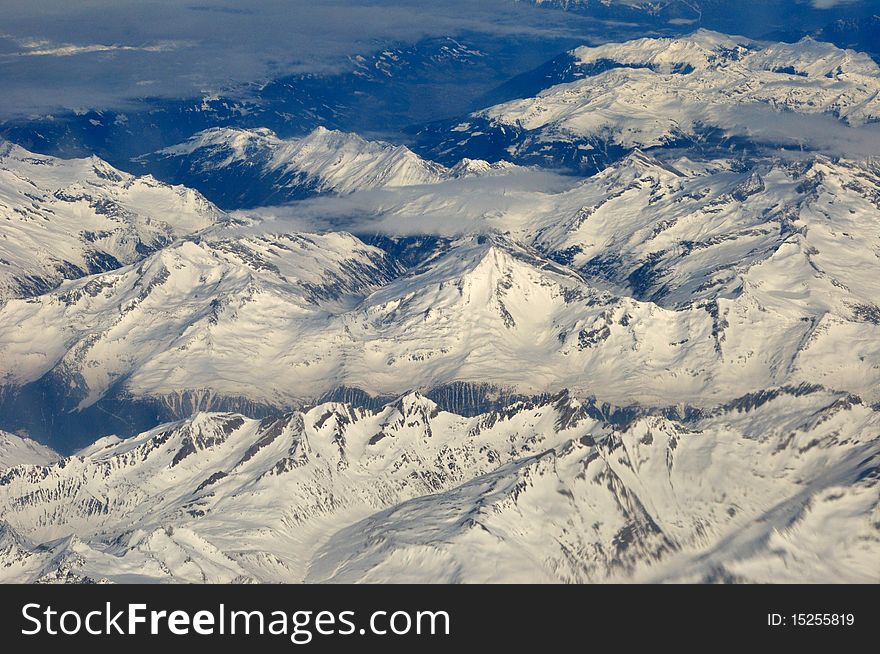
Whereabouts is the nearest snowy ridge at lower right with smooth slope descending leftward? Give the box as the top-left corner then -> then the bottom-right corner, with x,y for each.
307,390 -> 880,583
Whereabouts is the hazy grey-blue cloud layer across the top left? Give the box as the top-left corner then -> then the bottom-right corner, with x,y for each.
0,0 -> 596,116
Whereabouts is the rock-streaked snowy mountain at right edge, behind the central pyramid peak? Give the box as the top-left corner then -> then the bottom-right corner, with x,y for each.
524,152 -> 880,317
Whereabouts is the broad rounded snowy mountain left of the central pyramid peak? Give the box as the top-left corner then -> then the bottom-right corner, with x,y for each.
0,234 -> 399,447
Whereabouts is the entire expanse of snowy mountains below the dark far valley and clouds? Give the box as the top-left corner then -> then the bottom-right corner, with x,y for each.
0,32 -> 880,583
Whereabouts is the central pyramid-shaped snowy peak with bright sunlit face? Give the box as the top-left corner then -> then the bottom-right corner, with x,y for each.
341,235 -> 714,400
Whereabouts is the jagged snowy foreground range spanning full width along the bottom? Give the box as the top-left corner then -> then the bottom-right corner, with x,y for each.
0,387 -> 880,582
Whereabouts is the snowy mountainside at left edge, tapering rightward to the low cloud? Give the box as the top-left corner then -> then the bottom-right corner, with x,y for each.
0,143 -> 228,304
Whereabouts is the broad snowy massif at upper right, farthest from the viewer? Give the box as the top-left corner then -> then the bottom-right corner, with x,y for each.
420,30 -> 880,172
